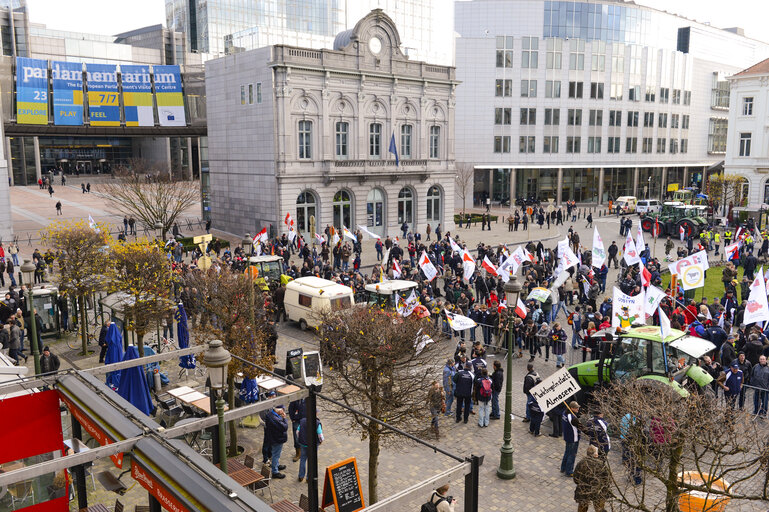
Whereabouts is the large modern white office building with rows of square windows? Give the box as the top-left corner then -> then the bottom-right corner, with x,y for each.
455,0 -> 769,206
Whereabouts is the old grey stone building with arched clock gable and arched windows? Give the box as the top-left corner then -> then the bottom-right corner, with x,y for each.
206,10 -> 457,238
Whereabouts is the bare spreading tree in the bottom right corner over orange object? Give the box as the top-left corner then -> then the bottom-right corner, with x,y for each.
595,380 -> 769,512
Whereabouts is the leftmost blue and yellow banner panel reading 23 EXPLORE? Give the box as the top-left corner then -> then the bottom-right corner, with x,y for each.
16,57 -> 48,124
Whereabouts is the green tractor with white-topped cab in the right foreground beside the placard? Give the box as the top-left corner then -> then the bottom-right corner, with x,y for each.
569,325 -> 716,403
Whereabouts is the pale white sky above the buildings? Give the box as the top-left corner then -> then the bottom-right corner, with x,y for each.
22,0 -> 769,41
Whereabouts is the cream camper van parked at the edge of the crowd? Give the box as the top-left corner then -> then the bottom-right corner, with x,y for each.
284,276 -> 355,330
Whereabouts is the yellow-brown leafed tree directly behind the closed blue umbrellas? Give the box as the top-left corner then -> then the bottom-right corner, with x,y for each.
109,239 -> 174,357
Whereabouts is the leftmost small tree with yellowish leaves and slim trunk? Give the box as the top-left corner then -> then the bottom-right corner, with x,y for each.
41,220 -> 112,355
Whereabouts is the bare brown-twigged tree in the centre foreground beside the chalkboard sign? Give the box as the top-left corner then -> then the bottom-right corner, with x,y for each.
319,306 -> 439,503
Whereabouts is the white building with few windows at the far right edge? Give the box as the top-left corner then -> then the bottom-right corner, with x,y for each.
724,59 -> 769,210
